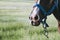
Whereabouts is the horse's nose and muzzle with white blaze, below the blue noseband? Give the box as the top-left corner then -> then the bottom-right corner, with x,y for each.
29,6 -> 44,26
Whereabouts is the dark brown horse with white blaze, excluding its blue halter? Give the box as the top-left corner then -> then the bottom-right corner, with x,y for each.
29,0 -> 60,33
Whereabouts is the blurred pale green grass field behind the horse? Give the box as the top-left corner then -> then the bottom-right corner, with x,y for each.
0,1 -> 60,40
